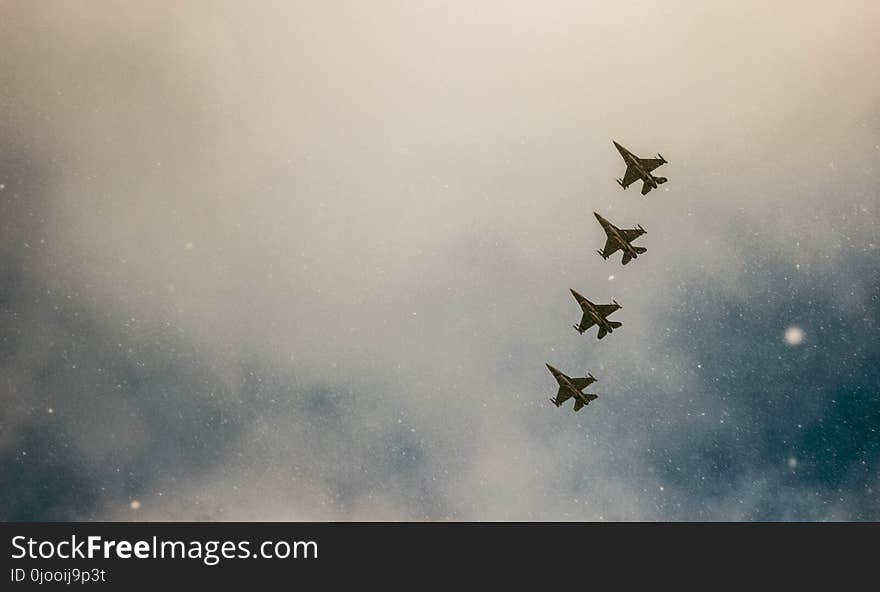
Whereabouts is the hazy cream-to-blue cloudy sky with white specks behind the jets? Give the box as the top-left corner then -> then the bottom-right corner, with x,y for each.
0,0 -> 880,521
